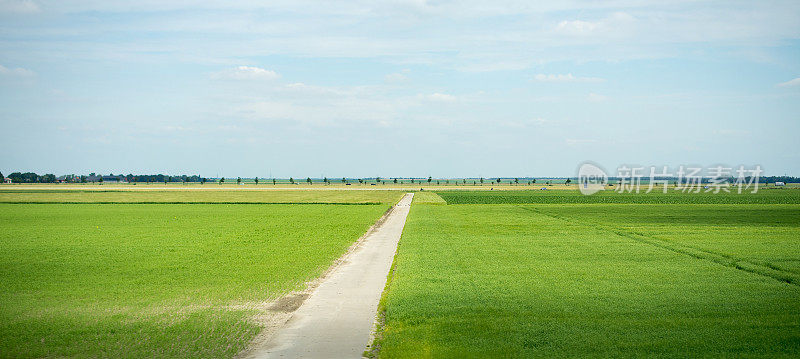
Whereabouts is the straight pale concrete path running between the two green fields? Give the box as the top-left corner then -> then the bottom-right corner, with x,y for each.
250,193 -> 414,358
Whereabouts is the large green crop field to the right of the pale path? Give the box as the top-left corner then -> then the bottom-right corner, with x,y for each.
375,190 -> 800,358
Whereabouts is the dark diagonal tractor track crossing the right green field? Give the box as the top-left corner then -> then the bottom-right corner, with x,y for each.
519,206 -> 800,286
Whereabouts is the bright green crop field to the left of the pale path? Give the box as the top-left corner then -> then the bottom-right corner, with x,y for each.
0,202 -> 388,358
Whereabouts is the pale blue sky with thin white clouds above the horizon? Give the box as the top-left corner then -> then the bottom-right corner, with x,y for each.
0,0 -> 800,178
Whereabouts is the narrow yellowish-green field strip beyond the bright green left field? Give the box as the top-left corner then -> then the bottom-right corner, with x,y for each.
0,186 -> 404,204
